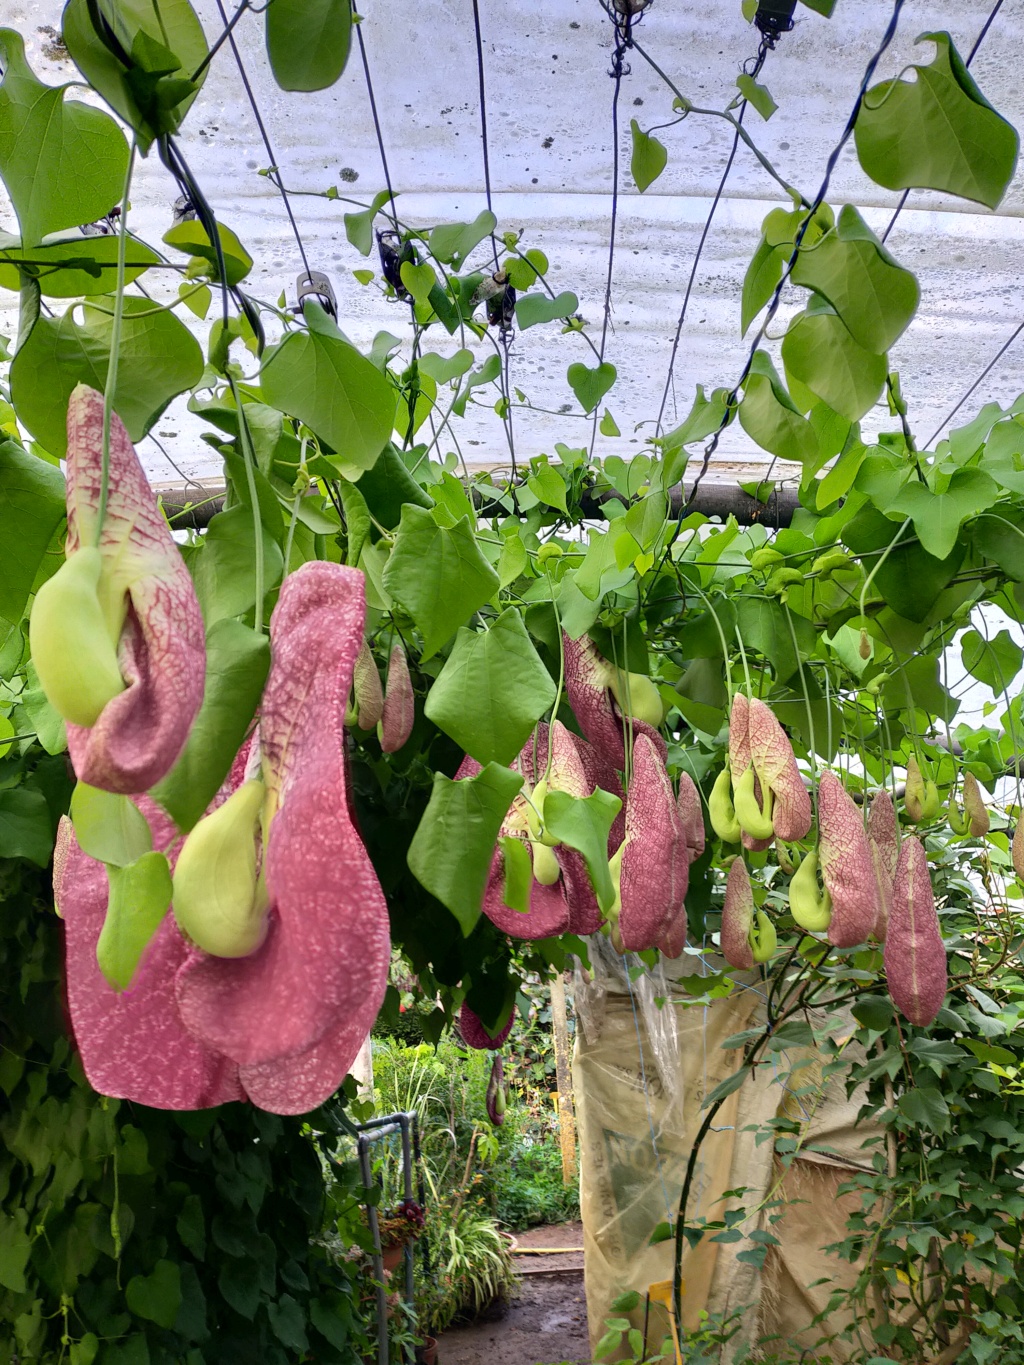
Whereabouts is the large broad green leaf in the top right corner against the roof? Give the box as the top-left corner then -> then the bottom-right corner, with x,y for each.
853,33 -> 1019,209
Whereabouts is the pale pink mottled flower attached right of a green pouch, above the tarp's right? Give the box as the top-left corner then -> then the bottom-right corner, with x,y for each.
818,773 -> 878,947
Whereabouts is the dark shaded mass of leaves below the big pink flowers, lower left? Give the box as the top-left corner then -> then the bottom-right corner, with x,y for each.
0,860 -> 369,1365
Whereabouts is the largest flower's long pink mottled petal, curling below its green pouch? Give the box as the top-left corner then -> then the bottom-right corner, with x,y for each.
176,561 -> 390,1114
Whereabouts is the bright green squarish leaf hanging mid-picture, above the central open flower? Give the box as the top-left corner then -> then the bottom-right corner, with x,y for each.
425,607 -> 554,763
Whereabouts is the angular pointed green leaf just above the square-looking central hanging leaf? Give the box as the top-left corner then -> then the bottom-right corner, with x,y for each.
384,505 -> 498,658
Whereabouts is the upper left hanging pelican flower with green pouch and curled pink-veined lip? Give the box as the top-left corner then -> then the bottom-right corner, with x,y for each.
29,384 -> 206,793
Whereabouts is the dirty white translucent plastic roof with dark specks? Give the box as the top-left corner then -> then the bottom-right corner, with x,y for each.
0,0 -> 1024,483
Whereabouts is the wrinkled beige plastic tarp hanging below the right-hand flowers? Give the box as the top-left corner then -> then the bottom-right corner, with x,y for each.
573,945 -> 879,1361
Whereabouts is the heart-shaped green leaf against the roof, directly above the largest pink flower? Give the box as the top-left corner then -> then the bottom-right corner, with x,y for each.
261,300 -> 396,479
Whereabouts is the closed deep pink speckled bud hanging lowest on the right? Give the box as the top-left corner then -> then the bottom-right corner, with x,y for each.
885,838 -> 948,1026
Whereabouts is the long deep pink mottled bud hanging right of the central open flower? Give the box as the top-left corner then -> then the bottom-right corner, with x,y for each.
618,734 -> 689,953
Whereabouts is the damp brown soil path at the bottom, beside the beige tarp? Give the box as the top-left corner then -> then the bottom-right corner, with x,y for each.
437,1223 -> 590,1365
